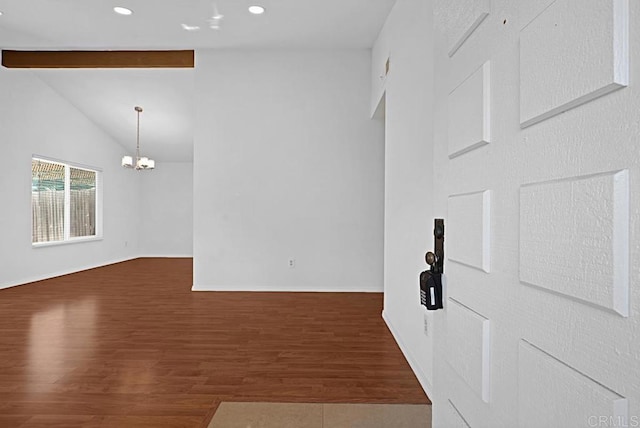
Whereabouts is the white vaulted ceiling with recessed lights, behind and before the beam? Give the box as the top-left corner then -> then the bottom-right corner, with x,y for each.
0,0 -> 395,161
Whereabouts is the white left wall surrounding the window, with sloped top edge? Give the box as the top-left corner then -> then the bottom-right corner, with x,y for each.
0,68 -> 139,288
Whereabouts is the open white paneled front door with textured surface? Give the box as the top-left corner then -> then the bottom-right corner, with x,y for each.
433,0 -> 640,428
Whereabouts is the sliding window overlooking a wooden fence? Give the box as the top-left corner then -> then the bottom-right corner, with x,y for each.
31,157 -> 100,245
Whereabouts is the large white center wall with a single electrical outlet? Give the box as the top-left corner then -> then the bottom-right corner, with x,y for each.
194,50 -> 383,291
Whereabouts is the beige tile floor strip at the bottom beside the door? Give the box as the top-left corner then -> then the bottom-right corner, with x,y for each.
209,402 -> 431,428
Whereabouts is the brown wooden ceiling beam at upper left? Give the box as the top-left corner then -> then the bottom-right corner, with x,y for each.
2,50 -> 195,68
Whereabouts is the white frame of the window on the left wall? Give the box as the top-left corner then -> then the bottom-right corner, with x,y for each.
30,154 -> 104,248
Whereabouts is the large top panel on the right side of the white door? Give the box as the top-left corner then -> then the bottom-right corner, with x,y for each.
520,0 -> 629,127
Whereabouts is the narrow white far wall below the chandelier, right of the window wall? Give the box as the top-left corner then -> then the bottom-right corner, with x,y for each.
139,162 -> 193,257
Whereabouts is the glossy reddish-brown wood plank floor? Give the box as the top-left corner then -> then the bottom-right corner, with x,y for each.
0,259 -> 429,428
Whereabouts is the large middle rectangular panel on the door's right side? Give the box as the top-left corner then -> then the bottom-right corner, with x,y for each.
520,170 -> 629,317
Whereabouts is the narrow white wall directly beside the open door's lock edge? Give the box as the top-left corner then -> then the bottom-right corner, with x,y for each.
371,0 -> 433,393
